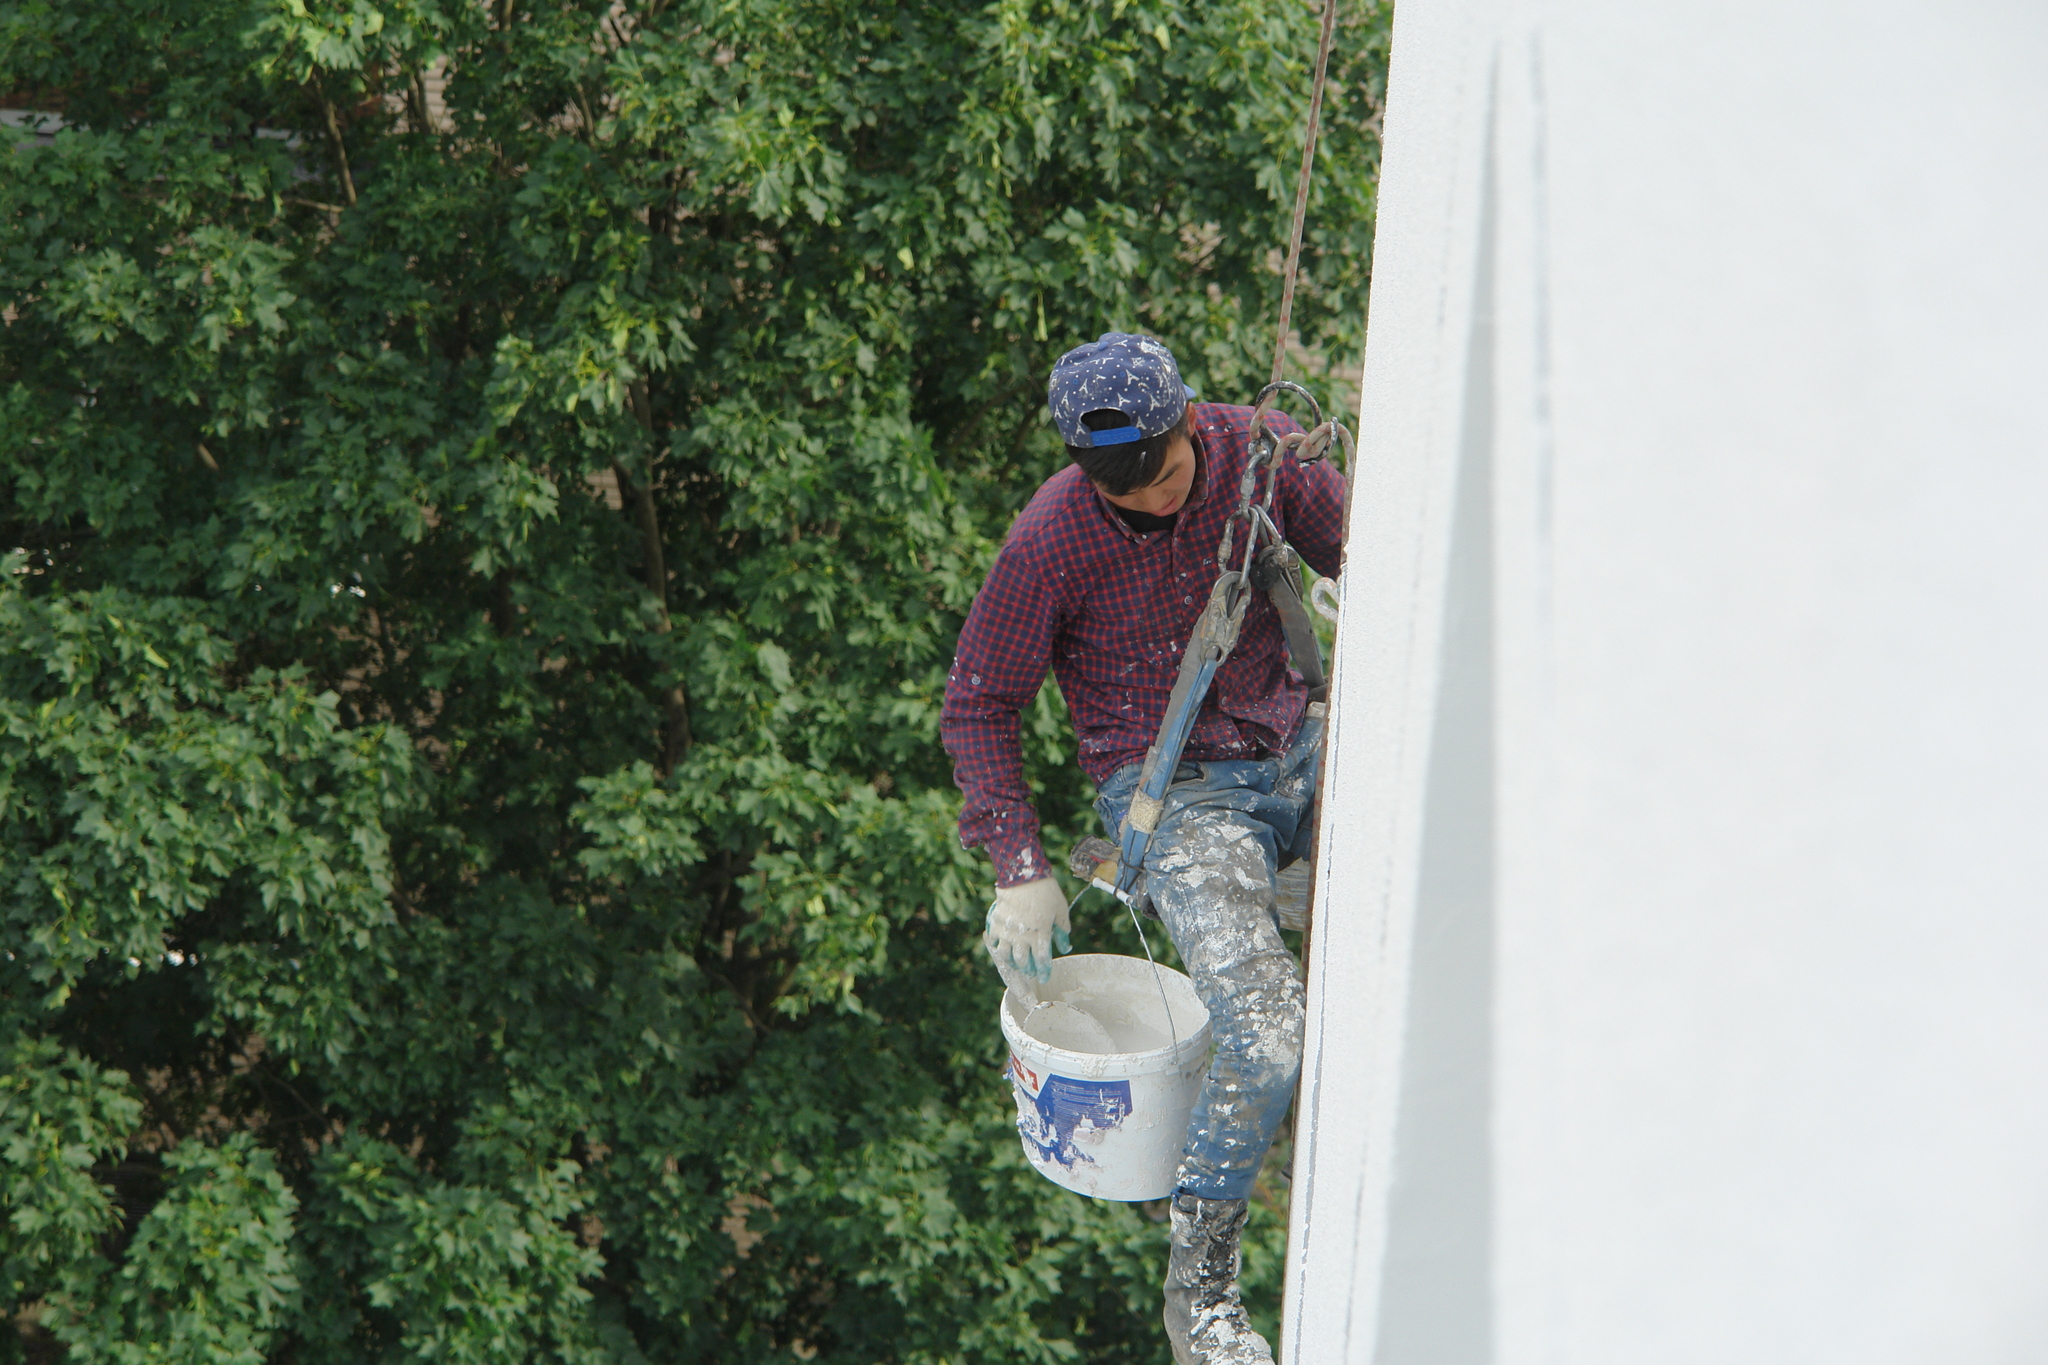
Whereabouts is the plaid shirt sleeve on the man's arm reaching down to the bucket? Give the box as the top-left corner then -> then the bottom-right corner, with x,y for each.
938,548 -> 1059,886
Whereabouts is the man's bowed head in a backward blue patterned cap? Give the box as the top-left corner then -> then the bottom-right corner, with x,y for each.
1047,332 -> 1194,516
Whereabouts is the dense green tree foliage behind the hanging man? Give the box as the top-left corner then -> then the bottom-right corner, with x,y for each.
0,0 -> 1384,1365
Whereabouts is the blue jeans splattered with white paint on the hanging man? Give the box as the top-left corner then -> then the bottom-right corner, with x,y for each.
1096,716 -> 1323,1199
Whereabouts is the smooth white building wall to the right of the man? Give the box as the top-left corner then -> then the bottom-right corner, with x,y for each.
1284,0 -> 2048,1365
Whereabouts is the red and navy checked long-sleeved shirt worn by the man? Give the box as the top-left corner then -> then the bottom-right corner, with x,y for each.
940,403 -> 1343,886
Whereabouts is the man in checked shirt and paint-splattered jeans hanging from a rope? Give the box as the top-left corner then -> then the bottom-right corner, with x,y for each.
940,332 -> 1343,1365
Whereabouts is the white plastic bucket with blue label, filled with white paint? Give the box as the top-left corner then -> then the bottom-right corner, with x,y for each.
999,954 -> 1208,1201
